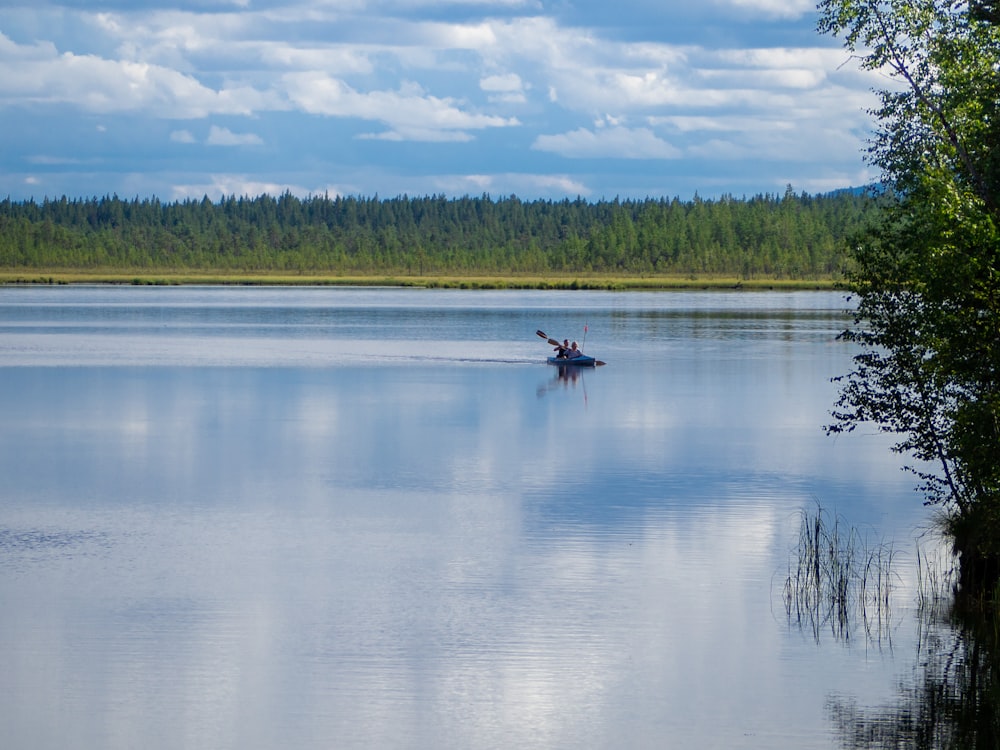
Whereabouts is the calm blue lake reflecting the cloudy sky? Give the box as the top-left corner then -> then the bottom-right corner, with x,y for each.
0,286 -> 930,750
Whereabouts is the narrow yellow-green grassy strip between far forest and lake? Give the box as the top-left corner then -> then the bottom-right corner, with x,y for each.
0,269 -> 844,291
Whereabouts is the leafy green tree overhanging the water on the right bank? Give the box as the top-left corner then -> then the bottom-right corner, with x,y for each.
819,0 -> 1000,598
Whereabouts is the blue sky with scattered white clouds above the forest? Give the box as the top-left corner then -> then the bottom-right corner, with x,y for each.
0,0 -> 880,206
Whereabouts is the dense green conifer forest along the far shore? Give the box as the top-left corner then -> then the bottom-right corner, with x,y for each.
0,186 -> 876,279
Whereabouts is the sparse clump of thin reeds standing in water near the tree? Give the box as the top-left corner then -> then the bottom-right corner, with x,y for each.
782,505 -> 899,641
